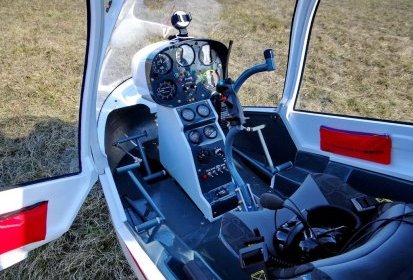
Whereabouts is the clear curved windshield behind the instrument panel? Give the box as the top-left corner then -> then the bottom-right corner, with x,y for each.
98,0 -> 295,108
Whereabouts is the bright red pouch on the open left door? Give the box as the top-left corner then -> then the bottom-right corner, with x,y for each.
0,201 -> 47,254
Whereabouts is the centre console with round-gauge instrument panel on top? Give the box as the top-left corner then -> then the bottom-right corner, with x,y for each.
132,38 -> 238,221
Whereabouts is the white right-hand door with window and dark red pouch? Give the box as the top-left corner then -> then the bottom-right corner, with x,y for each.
278,0 -> 413,183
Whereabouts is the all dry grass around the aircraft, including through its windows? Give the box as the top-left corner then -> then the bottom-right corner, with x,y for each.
0,0 -> 413,279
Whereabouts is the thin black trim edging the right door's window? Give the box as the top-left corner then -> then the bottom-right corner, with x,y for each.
292,0 -> 413,126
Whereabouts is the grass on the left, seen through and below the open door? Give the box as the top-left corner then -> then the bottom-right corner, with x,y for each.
0,0 -> 132,279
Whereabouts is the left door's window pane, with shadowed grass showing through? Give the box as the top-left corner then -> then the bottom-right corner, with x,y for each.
0,0 -> 87,190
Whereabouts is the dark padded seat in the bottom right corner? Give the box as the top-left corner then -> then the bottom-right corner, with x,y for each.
271,203 -> 413,280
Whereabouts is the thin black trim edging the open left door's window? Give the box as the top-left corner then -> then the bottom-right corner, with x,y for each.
0,1 -> 91,190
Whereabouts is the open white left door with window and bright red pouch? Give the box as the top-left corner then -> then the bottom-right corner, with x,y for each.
0,1 -> 111,270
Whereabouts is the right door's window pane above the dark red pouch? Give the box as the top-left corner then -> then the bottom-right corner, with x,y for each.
296,0 -> 413,122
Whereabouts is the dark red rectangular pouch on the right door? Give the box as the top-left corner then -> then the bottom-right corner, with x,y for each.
320,126 -> 392,164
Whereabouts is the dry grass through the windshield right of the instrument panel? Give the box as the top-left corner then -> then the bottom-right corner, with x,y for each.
210,0 -> 295,106
